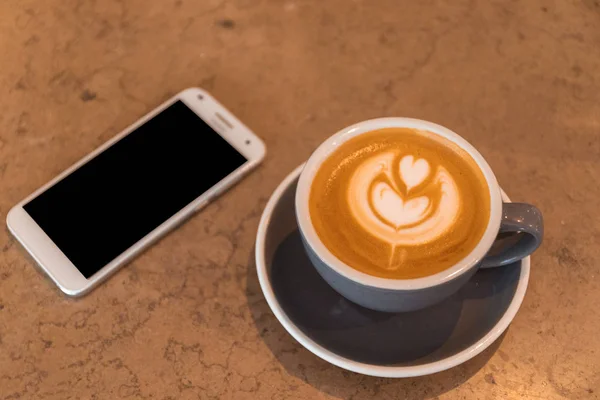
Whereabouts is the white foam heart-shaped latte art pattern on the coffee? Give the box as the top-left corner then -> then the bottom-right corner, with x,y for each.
347,152 -> 460,248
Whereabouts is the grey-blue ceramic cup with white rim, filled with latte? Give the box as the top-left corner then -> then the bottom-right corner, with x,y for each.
295,118 -> 543,312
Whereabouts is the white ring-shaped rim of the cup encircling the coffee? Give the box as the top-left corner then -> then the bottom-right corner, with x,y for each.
295,117 -> 502,290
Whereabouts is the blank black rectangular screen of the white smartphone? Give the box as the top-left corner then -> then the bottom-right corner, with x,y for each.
24,101 -> 247,278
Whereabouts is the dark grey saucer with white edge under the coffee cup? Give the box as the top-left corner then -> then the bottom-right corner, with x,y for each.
256,165 -> 530,378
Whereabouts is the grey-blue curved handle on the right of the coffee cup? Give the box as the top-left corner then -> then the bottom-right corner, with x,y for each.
480,203 -> 544,268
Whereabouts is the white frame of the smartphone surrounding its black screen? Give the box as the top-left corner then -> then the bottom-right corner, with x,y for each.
6,88 -> 266,296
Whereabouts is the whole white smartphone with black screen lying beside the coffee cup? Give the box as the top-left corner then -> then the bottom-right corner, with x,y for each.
6,88 -> 265,296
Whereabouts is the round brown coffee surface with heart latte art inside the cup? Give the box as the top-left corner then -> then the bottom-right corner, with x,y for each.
309,128 -> 490,279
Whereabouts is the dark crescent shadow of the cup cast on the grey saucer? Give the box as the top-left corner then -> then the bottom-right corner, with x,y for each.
271,230 -> 462,365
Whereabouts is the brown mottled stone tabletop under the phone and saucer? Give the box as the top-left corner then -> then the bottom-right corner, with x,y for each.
0,0 -> 600,400
